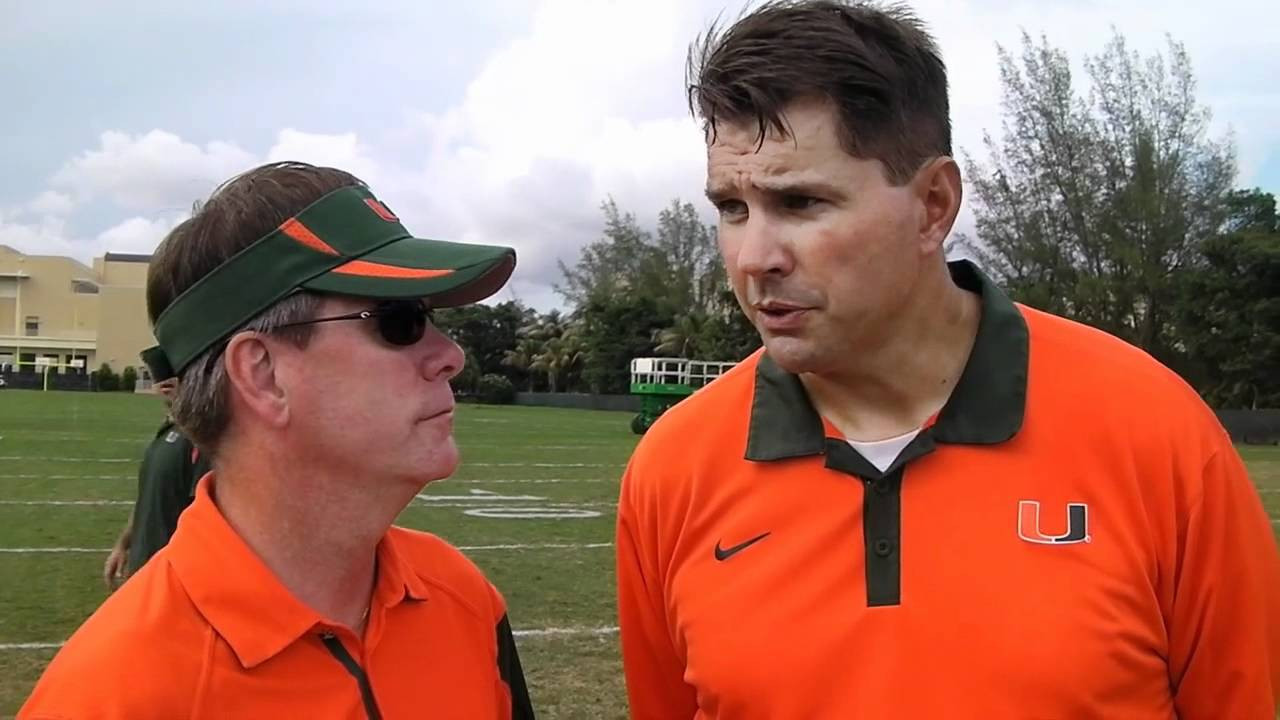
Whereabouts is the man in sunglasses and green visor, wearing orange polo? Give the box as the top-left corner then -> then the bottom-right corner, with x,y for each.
18,163 -> 532,720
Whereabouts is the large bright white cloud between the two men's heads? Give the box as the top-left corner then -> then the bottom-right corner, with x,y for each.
396,0 -> 709,297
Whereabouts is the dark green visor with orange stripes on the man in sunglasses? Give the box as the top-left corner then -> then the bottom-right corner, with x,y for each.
148,187 -> 516,374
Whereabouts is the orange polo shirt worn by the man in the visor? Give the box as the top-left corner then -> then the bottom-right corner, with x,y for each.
18,474 -> 532,720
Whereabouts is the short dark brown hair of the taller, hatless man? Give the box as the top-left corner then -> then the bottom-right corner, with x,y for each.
686,0 -> 951,184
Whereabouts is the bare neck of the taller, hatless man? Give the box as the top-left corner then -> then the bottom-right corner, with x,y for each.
800,269 -> 982,442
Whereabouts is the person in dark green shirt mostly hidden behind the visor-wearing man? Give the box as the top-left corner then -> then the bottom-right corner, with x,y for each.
102,347 -> 211,589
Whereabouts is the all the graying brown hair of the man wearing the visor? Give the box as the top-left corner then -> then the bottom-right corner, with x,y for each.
147,161 -> 365,453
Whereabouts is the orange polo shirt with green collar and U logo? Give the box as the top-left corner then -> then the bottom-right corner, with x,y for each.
617,263 -> 1280,720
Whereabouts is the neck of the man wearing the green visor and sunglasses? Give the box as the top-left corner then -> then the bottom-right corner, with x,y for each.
214,460 -> 394,634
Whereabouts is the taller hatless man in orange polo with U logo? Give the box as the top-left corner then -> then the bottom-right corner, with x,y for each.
616,0 -> 1280,720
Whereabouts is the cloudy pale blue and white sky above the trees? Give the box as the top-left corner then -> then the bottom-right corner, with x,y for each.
0,0 -> 1280,310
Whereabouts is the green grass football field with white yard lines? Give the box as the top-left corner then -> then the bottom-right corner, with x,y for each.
0,391 -> 1280,720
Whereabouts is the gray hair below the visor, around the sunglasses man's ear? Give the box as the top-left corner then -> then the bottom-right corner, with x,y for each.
169,292 -> 320,457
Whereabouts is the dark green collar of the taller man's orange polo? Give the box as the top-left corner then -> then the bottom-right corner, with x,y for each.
746,260 -> 1029,461
